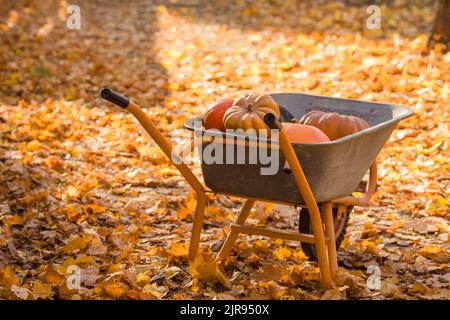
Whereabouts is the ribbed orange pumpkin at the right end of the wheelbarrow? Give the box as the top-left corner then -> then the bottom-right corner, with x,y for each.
299,110 -> 369,140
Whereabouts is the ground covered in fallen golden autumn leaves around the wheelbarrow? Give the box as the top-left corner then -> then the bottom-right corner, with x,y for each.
0,0 -> 450,299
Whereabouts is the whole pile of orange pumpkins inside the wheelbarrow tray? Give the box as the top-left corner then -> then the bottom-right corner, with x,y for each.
203,95 -> 369,143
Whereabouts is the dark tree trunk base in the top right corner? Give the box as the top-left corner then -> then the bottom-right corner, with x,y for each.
428,0 -> 450,50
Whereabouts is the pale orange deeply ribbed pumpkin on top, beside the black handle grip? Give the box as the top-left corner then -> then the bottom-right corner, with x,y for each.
223,95 -> 280,132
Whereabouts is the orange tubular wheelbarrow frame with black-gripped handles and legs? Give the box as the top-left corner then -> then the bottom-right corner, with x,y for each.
101,88 -> 377,288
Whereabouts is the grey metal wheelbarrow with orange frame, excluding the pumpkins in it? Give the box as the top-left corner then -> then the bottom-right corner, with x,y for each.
101,88 -> 413,287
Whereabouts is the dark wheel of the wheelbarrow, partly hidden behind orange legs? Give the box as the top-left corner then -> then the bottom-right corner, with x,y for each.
298,204 -> 353,261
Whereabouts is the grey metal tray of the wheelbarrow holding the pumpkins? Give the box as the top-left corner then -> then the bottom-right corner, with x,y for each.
185,93 -> 412,205
